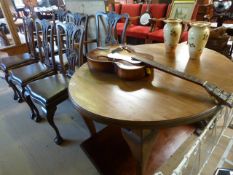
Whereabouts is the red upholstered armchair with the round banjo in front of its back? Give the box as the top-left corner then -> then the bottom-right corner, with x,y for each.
126,4 -> 167,39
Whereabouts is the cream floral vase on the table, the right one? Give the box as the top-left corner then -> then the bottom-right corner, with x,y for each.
188,21 -> 210,59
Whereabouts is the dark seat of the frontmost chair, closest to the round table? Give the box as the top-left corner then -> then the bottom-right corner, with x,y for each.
26,74 -> 69,105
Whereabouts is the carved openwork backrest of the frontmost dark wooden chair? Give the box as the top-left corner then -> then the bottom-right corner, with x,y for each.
56,22 -> 84,76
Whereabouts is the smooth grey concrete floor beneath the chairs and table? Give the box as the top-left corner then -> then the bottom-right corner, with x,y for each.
0,76 -> 233,175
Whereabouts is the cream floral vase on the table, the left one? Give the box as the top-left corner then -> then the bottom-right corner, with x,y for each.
163,19 -> 182,52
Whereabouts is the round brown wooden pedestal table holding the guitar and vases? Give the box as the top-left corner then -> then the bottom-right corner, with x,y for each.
69,43 -> 233,175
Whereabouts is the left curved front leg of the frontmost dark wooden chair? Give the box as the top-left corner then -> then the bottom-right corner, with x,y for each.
22,88 -> 41,122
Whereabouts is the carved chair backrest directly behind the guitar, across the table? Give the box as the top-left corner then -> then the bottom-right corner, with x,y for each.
95,12 -> 129,46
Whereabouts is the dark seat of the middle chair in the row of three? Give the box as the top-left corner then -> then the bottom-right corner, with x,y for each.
10,62 -> 54,85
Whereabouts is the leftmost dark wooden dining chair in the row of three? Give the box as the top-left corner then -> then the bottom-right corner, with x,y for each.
0,17 -> 39,102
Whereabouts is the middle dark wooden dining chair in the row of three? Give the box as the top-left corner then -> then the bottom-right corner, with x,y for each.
9,19 -> 57,106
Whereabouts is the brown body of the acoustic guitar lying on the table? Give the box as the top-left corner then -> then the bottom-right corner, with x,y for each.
87,46 -> 153,81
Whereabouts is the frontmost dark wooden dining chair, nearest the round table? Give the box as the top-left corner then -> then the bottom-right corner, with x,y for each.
26,23 -> 84,145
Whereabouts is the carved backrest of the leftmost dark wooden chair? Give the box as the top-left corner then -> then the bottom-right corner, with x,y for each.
23,17 -> 38,58
